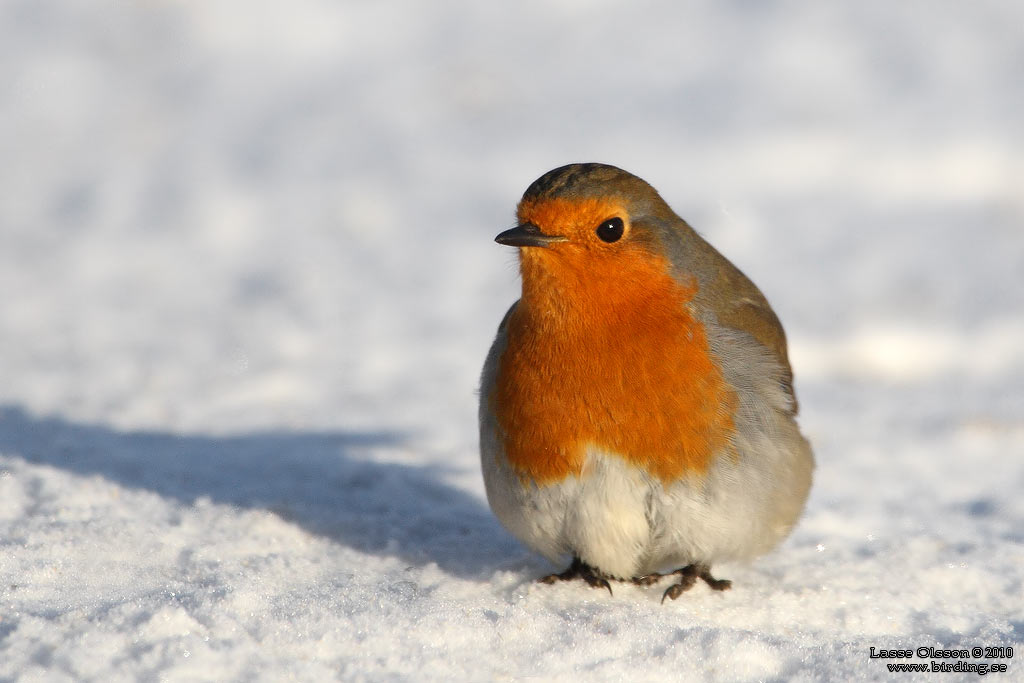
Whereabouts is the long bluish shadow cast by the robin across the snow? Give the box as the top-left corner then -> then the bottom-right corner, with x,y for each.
0,407 -> 521,579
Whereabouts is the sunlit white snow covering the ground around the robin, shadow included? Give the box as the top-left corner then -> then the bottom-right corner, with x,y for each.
0,0 -> 1024,681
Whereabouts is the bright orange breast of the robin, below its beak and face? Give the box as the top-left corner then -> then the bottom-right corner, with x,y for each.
490,250 -> 735,483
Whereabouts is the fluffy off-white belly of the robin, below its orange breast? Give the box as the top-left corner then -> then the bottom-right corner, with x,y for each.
483,438 -> 803,579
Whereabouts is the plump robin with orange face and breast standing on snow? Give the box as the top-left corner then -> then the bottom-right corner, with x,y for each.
479,163 -> 814,603
